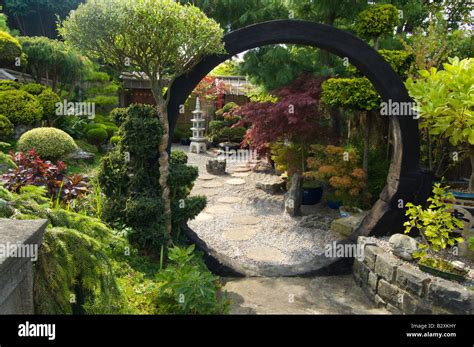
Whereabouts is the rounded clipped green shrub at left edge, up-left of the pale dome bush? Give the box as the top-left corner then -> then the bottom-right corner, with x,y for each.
0,90 -> 43,125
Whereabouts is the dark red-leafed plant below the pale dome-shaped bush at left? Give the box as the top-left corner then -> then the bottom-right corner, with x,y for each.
3,150 -> 89,203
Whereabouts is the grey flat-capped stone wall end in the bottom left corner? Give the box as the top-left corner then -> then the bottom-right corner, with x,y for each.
0,219 -> 48,314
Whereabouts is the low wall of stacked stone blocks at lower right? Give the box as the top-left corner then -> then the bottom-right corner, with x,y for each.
353,237 -> 474,314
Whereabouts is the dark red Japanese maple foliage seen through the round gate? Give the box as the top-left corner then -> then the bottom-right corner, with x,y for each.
236,75 -> 331,152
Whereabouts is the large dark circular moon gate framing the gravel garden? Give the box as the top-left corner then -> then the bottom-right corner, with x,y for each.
168,20 -> 432,276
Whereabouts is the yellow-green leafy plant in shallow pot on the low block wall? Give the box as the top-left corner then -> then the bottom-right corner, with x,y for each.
404,183 -> 467,281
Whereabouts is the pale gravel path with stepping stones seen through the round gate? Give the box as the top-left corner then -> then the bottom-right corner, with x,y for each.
173,146 -> 341,275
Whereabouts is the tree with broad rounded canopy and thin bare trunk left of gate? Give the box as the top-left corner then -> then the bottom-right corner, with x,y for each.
60,0 -> 224,247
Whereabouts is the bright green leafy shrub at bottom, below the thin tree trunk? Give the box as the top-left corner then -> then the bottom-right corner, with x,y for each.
156,245 -> 228,314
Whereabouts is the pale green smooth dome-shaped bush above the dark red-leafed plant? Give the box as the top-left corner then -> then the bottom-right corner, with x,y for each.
17,128 -> 77,161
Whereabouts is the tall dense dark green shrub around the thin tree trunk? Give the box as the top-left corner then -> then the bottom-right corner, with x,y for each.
98,105 -> 206,255
